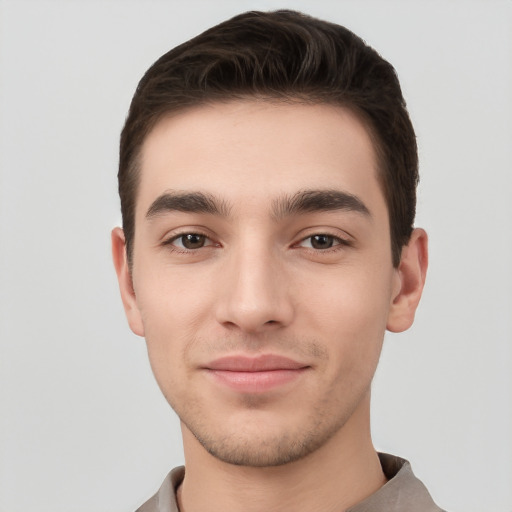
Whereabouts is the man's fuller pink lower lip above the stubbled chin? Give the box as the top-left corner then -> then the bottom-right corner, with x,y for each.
209,368 -> 306,393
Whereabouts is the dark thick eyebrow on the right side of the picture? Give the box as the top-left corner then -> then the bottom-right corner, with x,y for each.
273,190 -> 371,219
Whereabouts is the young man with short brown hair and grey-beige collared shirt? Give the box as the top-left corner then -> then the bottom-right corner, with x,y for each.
112,11 -> 440,512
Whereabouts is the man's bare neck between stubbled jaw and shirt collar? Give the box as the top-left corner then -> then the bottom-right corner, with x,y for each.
178,397 -> 386,512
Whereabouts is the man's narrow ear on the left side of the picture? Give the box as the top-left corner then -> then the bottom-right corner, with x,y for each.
111,228 -> 144,336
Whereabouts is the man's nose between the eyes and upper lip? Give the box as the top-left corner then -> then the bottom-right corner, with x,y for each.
216,245 -> 294,334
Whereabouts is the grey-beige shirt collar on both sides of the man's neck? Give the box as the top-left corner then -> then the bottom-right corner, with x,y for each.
136,453 -> 443,512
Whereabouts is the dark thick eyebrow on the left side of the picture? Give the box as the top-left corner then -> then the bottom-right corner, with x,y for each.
146,190 -> 229,219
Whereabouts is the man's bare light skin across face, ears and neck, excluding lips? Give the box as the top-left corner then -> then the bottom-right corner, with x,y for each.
112,100 -> 427,512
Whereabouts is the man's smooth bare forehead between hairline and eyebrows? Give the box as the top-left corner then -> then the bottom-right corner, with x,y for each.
137,100 -> 384,216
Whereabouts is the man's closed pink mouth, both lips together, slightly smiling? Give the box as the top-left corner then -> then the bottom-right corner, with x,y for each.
203,354 -> 310,393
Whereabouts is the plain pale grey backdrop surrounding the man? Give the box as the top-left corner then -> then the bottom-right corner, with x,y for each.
0,0 -> 512,512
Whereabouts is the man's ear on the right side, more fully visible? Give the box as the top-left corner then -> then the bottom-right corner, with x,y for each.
386,228 -> 428,332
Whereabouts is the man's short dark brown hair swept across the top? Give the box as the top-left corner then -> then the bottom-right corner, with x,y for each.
118,10 -> 418,266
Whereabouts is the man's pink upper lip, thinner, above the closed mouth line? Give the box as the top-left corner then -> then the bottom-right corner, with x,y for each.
204,354 -> 308,372
